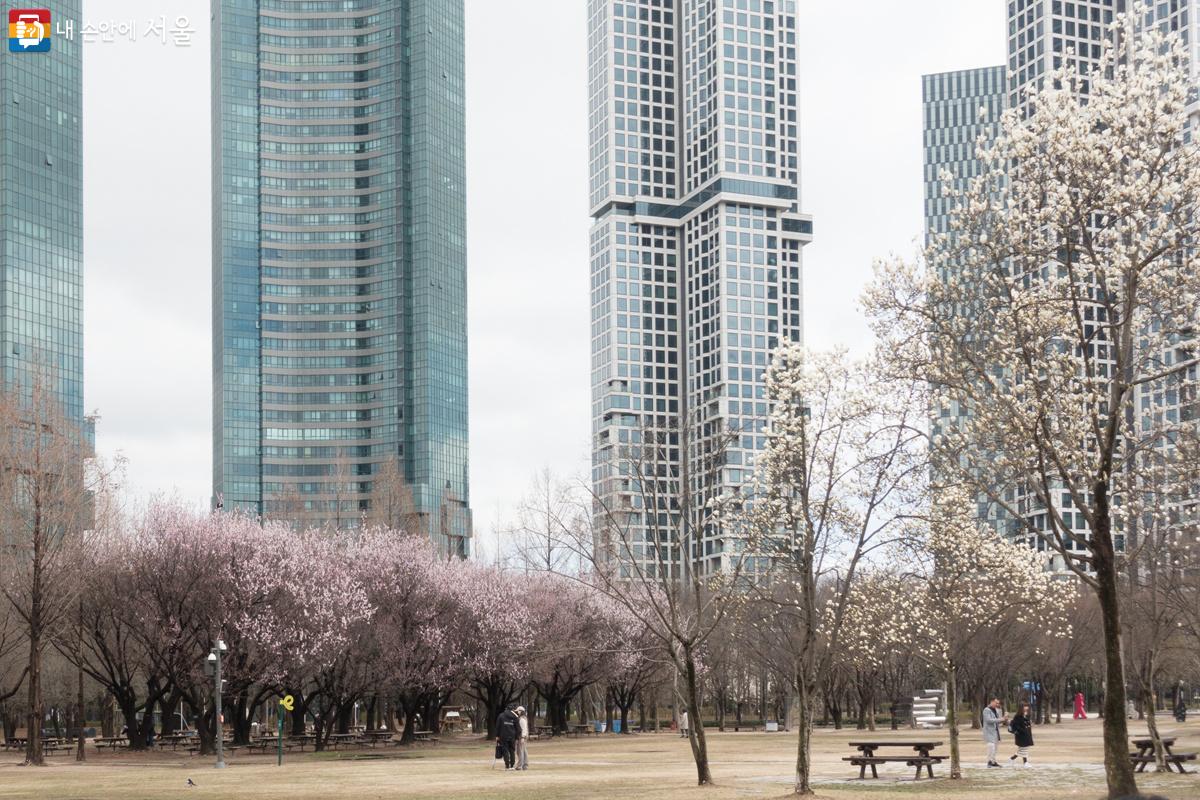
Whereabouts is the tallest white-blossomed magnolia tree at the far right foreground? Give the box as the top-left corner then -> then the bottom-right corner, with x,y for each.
866,28 -> 1200,798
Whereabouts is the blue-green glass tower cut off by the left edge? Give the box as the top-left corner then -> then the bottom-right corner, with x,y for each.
0,0 -> 83,424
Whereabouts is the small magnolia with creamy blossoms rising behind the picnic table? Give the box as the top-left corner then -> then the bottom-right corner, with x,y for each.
878,491 -> 1075,778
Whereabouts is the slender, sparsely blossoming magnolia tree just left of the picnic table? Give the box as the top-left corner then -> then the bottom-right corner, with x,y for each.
737,345 -> 925,794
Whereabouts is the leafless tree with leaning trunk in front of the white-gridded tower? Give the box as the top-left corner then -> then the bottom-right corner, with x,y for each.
572,414 -> 754,786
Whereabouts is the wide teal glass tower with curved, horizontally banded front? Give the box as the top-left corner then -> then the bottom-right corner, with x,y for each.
212,0 -> 470,553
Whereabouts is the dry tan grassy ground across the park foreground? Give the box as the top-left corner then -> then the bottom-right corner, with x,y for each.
0,721 -> 1200,800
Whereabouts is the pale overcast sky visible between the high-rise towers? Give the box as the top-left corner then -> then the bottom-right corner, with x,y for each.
76,0 -> 1004,549
